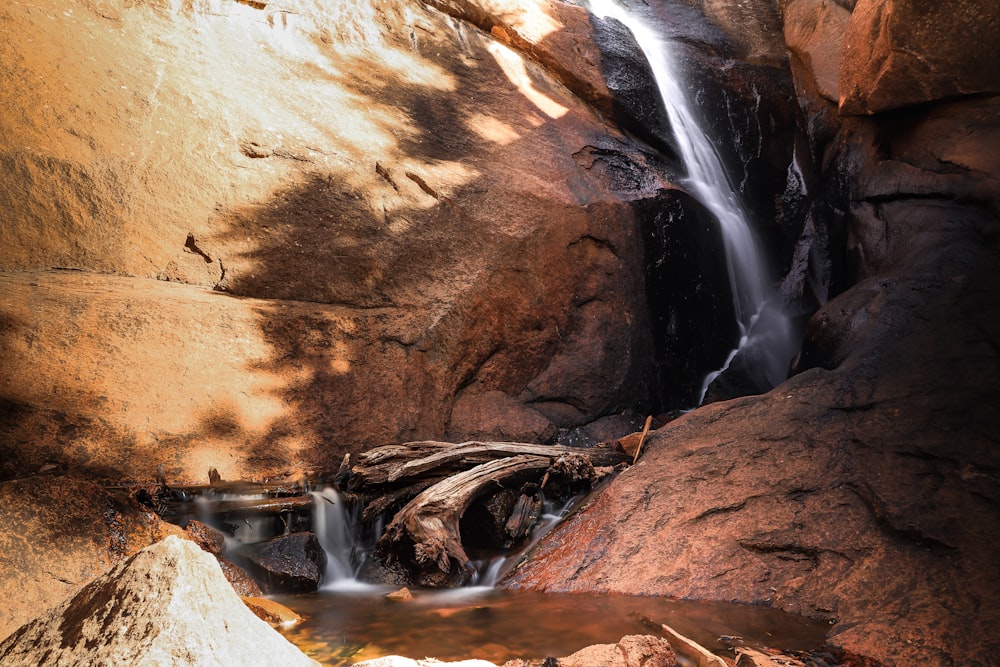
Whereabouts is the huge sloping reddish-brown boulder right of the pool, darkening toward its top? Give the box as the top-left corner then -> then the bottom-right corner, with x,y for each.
507,200 -> 1000,665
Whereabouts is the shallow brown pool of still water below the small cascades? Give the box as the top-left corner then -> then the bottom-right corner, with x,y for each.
276,588 -> 828,667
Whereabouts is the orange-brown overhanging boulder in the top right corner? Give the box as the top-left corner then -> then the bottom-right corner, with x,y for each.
840,0 -> 1000,114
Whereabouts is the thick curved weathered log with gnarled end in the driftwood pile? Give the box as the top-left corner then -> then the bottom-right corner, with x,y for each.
378,454 -> 551,576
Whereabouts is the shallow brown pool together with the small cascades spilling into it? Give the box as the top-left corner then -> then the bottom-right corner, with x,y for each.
165,487 -> 829,667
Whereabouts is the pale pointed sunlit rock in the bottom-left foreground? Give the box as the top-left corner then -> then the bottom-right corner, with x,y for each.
0,536 -> 318,666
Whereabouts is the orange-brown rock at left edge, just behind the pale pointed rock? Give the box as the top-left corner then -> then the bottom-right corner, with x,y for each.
0,476 -> 181,638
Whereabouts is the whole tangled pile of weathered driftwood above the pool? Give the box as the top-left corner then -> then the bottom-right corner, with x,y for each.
337,441 -> 629,585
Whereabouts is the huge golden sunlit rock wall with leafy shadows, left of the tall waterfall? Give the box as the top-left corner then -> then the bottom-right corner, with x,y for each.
0,0 -> 662,482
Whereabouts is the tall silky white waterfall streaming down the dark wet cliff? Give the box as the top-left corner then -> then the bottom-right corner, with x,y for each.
588,0 -> 794,404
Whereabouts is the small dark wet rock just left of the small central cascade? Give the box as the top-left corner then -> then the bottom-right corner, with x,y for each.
245,532 -> 326,593
